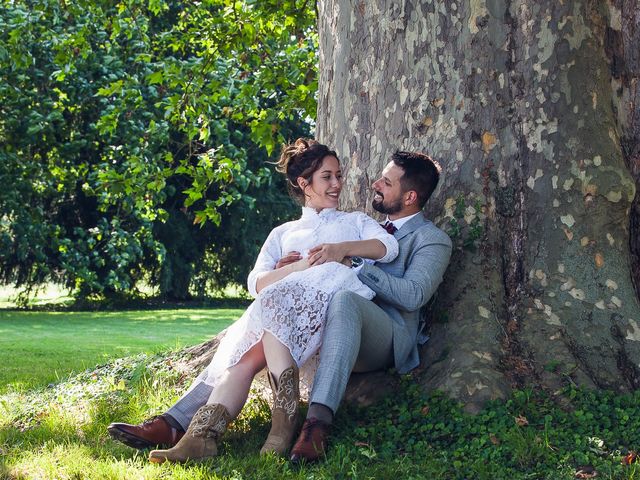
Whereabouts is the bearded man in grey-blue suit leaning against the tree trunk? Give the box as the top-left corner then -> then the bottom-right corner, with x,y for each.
108,152 -> 451,462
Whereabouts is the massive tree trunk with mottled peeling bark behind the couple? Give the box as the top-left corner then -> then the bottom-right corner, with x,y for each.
317,0 -> 640,409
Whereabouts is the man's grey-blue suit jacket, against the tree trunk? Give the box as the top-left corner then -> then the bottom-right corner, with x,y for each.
359,214 -> 451,373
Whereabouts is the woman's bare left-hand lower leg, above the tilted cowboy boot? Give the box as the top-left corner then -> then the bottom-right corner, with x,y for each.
207,342 -> 266,418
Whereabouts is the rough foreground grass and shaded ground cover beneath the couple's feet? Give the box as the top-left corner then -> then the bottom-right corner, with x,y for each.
0,344 -> 640,480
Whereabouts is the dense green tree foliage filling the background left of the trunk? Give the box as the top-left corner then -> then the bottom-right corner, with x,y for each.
0,0 -> 317,297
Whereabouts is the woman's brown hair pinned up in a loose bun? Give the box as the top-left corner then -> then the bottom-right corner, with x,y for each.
276,138 -> 340,203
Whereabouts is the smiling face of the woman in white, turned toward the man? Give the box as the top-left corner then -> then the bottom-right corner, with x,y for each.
298,155 -> 342,210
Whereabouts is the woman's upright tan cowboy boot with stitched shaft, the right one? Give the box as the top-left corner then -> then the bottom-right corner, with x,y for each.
260,365 -> 300,455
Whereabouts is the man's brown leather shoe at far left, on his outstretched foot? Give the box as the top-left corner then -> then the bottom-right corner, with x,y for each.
107,415 -> 184,450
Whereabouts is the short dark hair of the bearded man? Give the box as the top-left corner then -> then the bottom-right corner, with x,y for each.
391,151 -> 442,208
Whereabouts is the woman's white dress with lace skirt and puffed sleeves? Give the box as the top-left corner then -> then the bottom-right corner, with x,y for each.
203,207 -> 398,386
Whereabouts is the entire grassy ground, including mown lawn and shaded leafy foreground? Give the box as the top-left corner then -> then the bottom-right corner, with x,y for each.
0,309 -> 640,480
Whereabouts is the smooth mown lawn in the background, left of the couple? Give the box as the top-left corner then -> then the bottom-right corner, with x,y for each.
0,309 -> 242,393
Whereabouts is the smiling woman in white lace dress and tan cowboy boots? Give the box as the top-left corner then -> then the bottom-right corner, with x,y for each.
149,139 -> 398,463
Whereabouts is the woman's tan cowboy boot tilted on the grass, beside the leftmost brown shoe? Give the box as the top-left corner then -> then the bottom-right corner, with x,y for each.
149,403 -> 232,463
